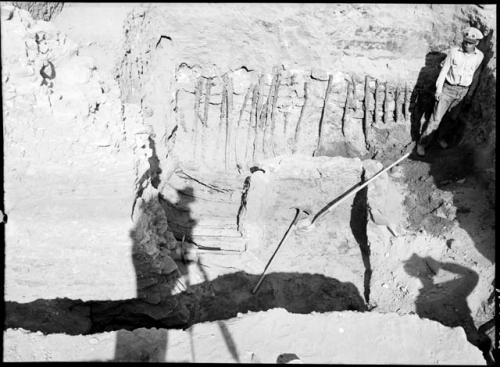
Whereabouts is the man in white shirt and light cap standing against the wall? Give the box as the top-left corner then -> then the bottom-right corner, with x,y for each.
417,27 -> 484,156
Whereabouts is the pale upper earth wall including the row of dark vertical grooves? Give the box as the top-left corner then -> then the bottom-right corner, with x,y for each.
117,4 -> 491,175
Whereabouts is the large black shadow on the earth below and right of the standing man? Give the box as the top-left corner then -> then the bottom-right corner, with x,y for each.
425,52 -> 496,263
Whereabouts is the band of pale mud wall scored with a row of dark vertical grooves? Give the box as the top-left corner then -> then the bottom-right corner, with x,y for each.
175,64 -> 412,171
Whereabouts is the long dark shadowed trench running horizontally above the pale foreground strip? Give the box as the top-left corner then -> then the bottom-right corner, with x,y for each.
4,272 -> 366,335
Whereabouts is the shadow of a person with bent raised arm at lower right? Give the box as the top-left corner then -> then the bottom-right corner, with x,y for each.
404,254 -> 491,360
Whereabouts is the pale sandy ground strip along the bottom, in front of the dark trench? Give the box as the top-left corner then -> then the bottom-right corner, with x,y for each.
4,309 -> 482,365
